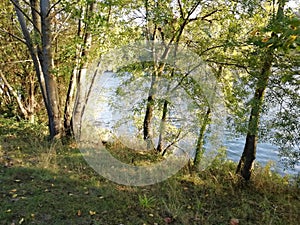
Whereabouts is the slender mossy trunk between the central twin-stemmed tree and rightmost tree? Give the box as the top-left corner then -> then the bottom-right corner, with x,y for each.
193,107 -> 211,171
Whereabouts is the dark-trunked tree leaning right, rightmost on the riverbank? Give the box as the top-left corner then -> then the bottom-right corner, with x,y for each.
236,0 -> 295,180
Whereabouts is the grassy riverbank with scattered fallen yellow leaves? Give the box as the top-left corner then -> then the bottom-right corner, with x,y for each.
0,119 -> 300,225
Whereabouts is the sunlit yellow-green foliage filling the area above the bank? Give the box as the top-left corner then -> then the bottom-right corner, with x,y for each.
0,0 -> 300,175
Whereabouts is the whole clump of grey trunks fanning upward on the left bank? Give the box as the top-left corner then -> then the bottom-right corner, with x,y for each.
11,0 -> 111,139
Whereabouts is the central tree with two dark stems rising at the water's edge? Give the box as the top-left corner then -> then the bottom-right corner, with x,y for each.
143,0 -> 219,152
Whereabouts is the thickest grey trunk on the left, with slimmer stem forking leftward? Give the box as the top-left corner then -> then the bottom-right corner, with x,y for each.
11,0 -> 62,139
